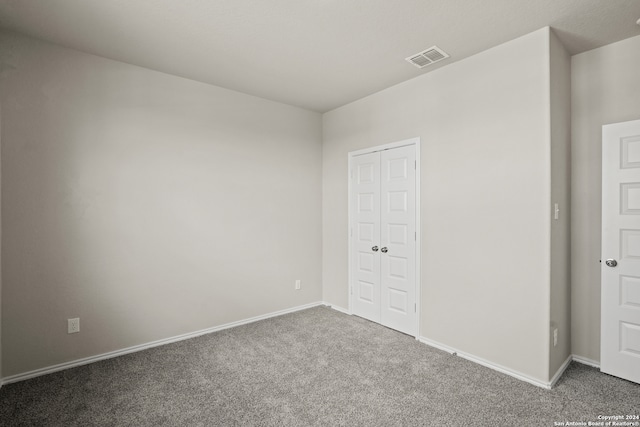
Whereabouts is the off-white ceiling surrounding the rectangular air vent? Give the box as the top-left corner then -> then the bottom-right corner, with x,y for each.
0,0 -> 640,112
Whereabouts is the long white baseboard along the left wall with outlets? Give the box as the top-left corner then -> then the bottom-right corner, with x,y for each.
0,301 -> 323,387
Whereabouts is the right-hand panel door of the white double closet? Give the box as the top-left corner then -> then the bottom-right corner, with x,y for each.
380,145 -> 417,335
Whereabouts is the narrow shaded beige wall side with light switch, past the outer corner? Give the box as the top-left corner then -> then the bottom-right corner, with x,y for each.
549,31 -> 571,378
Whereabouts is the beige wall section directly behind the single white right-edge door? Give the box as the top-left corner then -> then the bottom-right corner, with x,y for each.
571,36 -> 640,362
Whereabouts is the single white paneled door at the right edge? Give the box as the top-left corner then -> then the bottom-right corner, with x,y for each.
600,120 -> 640,383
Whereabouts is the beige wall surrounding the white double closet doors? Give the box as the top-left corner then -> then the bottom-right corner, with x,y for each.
322,28 -> 551,381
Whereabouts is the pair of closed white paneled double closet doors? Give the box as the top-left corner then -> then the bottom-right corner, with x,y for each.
350,145 -> 417,336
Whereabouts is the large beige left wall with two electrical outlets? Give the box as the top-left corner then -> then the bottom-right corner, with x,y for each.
0,34 -> 322,377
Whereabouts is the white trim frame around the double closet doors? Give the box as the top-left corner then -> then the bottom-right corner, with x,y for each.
347,137 -> 422,339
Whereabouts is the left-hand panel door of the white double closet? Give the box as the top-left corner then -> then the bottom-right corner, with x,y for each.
350,153 -> 380,322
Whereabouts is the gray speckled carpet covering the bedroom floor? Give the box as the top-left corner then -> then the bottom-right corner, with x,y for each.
0,307 -> 640,426
